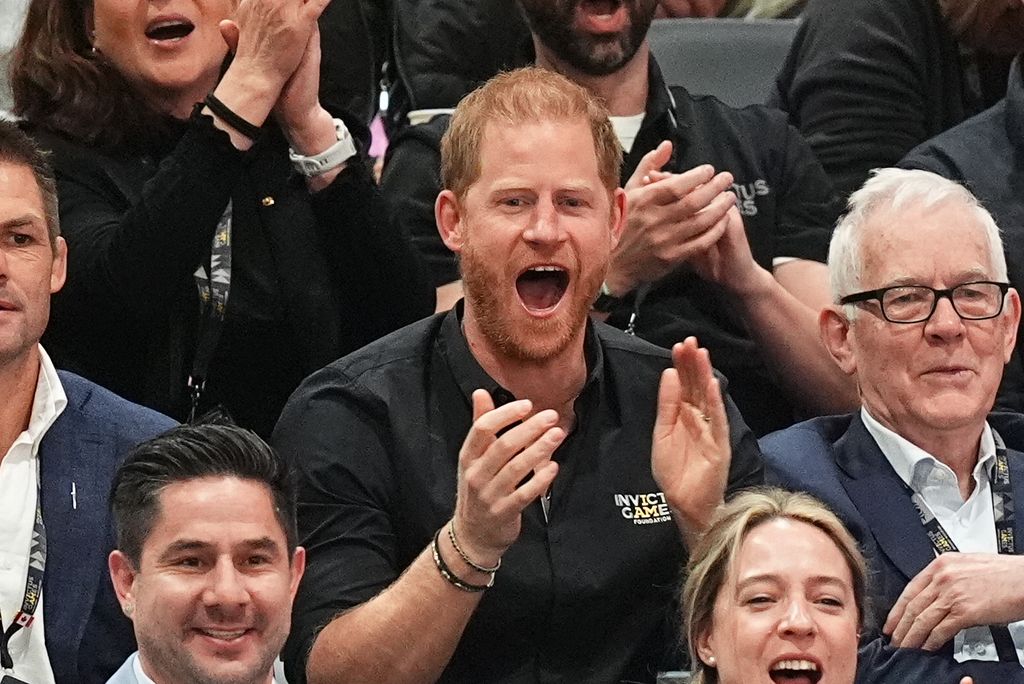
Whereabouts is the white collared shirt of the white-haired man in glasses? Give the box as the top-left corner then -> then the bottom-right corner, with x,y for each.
860,408 -> 1024,664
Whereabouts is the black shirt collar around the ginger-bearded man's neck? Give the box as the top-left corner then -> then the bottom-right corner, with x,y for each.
438,301 -> 604,407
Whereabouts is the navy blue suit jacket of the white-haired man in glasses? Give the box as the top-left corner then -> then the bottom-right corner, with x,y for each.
761,413 -> 1024,684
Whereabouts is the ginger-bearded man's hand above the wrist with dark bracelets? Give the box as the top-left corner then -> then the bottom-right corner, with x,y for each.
453,389 -> 565,567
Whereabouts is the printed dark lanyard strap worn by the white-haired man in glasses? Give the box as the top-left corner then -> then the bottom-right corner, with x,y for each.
903,430 -> 1019,662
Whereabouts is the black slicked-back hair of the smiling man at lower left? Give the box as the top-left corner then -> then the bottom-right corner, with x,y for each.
111,425 -> 298,567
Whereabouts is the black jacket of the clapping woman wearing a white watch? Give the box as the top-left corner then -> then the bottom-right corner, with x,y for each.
38,112 -> 433,434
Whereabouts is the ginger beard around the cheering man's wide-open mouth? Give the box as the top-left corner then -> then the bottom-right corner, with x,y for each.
460,233 -> 606,364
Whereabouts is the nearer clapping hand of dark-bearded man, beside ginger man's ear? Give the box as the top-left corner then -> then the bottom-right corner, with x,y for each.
606,141 -> 736,295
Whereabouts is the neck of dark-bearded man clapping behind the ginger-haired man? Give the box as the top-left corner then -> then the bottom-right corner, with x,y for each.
534,36 -> 650,117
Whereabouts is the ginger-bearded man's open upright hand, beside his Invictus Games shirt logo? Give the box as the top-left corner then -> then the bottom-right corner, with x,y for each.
651,337 -> 732,544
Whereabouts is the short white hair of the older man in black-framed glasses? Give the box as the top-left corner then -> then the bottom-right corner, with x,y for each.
828,169 -> 1008,318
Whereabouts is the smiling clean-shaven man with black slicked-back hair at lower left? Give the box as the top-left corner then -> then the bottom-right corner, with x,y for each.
109,425 -> 305,684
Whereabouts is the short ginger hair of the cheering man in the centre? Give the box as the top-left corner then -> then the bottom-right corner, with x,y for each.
441,67 -> 623,198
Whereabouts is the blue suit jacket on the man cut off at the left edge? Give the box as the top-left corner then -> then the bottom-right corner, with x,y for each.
39,372 -> 175,684
